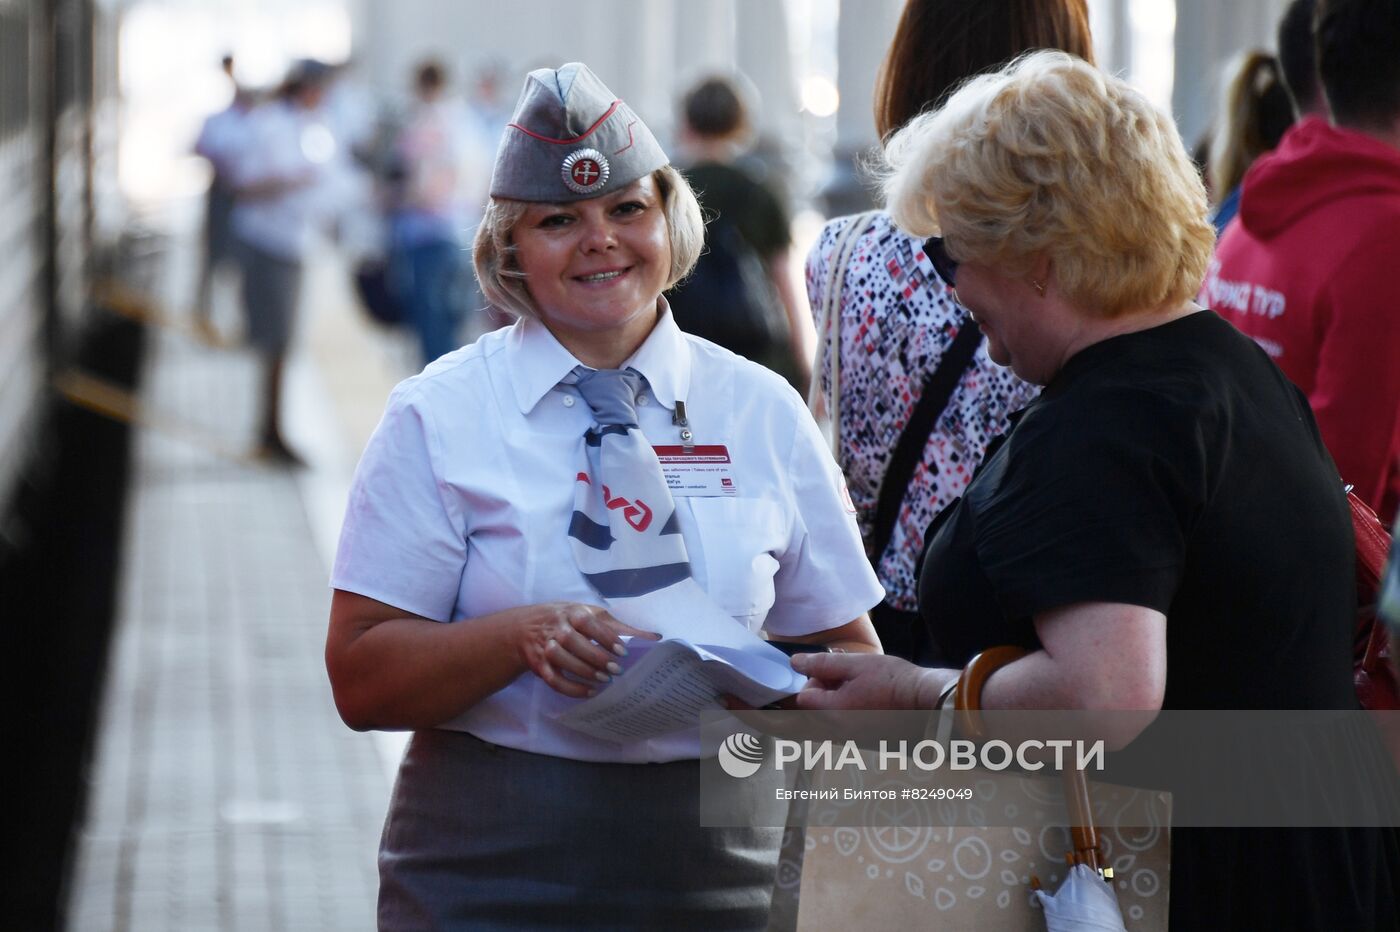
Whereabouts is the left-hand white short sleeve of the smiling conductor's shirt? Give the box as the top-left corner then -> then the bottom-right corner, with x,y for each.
330,386 -> 466,621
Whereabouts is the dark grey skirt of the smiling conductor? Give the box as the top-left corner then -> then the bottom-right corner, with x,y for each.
379,730 -> 783,932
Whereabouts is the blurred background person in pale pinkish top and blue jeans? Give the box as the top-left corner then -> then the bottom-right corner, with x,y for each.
391,60 -> 486,365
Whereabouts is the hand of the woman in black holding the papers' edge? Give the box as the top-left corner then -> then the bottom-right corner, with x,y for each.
792,654 -> 958,709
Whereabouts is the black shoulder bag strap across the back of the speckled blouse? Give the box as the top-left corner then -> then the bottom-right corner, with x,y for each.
869,240 -> 981,567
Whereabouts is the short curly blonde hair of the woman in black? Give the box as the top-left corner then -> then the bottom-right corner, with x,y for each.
883,50 -> 1215,318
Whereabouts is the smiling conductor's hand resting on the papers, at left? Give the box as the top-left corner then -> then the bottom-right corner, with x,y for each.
517,602 -> 661,698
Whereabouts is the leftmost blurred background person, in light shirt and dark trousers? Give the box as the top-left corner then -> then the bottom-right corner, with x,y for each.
195,55 -> 255,343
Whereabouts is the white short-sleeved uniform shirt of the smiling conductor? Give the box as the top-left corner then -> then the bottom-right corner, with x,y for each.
330,311 -> 883,763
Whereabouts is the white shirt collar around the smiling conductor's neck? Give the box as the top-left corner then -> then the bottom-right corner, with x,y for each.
507,298 -> 690,414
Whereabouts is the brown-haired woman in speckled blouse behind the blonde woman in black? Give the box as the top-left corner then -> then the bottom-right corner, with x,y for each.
806,0 -> 1093,659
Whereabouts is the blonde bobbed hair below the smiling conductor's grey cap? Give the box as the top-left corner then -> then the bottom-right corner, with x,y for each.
472,165 -> 704,319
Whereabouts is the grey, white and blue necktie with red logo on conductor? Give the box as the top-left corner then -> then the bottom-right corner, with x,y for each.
564,367 -> 704,603
